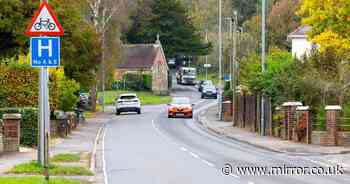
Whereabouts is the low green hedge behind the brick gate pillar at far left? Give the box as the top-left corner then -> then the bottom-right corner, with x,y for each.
0,108 -> 38,147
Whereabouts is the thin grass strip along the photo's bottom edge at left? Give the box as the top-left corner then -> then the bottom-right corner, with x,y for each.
0,176 -> 88,184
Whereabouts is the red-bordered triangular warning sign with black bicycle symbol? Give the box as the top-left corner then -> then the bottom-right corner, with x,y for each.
26,1 -> 64,36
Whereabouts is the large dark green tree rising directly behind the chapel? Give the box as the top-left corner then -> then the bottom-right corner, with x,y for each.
126,0 -> 211,57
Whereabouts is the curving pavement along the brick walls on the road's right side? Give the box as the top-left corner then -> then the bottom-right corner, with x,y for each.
198,105 -> 350,172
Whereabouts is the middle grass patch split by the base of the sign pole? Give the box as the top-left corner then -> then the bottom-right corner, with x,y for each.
8,161 -> 93,176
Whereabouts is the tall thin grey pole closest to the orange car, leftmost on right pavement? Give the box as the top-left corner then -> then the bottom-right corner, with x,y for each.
218,0 -> 222,120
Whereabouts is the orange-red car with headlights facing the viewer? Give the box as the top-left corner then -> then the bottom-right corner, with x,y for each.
168,97 -> 193,118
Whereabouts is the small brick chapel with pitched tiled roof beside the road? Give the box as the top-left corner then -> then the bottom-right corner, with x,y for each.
115,41 -> 169,95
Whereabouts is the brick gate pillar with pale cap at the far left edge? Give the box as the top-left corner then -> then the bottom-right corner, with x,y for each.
2,114 -> 21,152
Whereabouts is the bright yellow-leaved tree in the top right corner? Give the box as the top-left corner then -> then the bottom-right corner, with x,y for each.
298,0 -> 350,57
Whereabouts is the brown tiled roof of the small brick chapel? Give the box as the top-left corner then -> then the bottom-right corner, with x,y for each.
117,44 -> 161,69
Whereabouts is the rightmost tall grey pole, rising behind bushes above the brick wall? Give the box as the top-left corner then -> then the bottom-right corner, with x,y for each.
260,0 -> 266,136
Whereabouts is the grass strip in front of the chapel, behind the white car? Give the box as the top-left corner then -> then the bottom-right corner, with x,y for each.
98,90 -> 171,105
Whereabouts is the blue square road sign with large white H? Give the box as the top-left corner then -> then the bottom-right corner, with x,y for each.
30,37 -> 60,67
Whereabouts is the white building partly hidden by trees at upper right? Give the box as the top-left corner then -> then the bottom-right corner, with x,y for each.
288,25 -> 315,59
